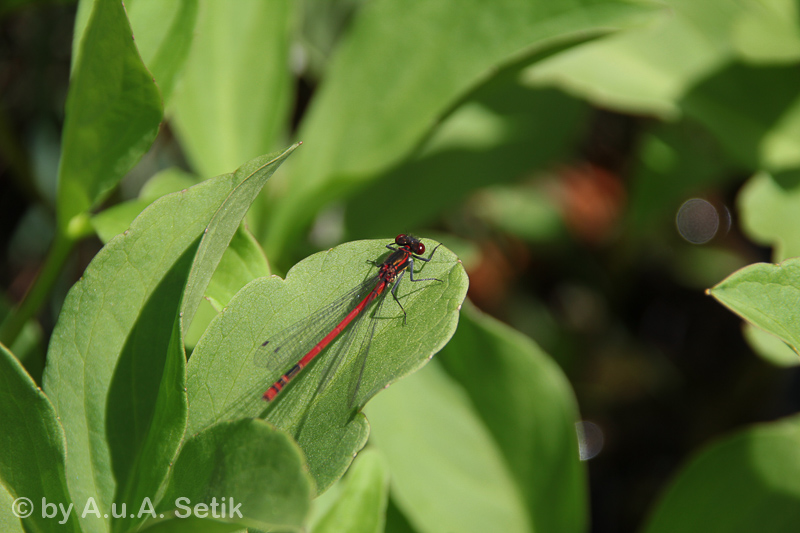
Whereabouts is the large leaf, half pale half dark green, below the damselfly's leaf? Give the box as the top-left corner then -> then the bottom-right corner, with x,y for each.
367,307 -> 587,532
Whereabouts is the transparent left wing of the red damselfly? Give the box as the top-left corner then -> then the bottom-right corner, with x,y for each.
253,274 -> 378,374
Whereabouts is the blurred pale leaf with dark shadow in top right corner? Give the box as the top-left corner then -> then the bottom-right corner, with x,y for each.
524,0 -> 800,170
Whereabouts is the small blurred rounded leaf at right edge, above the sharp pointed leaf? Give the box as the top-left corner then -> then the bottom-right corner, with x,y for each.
737,171 -> 800,261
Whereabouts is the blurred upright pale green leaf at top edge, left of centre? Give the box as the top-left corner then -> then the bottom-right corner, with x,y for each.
172,0 -> 292,177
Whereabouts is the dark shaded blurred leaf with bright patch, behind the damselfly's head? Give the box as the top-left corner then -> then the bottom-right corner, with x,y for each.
346,81 -> 586,237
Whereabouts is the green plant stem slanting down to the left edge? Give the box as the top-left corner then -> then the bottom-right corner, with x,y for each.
0,231 -> 75,347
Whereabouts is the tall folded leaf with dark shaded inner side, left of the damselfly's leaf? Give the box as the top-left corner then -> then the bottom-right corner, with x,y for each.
44,147 -> 295,531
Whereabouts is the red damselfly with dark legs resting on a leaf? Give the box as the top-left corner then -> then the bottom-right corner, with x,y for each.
255,234 -> 441,404
